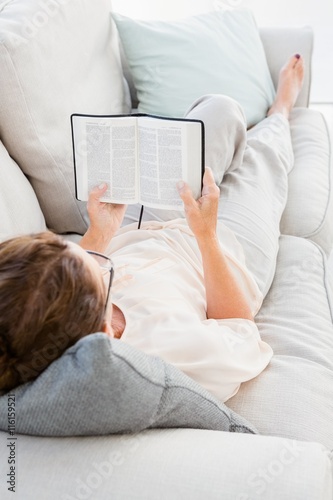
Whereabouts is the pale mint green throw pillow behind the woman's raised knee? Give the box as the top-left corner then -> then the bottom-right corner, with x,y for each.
113,10 -> 275,126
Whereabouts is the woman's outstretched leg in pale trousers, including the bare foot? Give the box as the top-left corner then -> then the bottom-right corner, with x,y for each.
215,55 -> 304,295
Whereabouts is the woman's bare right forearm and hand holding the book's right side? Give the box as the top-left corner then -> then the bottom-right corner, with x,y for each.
178,168 -> 253,320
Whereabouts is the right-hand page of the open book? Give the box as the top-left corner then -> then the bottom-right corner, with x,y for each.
138,117 -> 202,209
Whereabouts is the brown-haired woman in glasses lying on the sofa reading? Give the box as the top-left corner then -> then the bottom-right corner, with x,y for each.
0,55 -> 304,401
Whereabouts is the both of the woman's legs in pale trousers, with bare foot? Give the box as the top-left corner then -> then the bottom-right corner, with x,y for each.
184,56 -> 304,295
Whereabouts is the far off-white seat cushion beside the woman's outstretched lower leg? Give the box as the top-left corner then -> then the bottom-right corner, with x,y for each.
281,108 -> 333,254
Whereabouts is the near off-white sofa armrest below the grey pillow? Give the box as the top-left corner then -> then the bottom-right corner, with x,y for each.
0,428 -> 333,500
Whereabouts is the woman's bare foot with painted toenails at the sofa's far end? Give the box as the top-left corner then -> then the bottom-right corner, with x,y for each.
267,54 -> 304,118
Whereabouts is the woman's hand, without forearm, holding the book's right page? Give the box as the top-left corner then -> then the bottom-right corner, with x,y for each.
177,167 -> 220,241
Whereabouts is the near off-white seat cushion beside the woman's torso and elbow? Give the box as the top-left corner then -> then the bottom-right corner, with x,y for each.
227,236 -> 333,449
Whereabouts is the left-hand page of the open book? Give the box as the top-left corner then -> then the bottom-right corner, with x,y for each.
73,115 -> 138,203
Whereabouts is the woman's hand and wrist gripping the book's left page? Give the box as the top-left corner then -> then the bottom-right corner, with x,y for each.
79,184 -> 126,253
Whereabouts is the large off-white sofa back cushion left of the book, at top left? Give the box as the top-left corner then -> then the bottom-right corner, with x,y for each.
0,0 -> 129,233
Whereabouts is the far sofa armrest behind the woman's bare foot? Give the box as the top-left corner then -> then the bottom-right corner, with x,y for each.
259,26 -> 313,107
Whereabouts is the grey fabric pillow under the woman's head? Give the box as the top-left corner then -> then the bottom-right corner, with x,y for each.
0,333 -> 256,436
